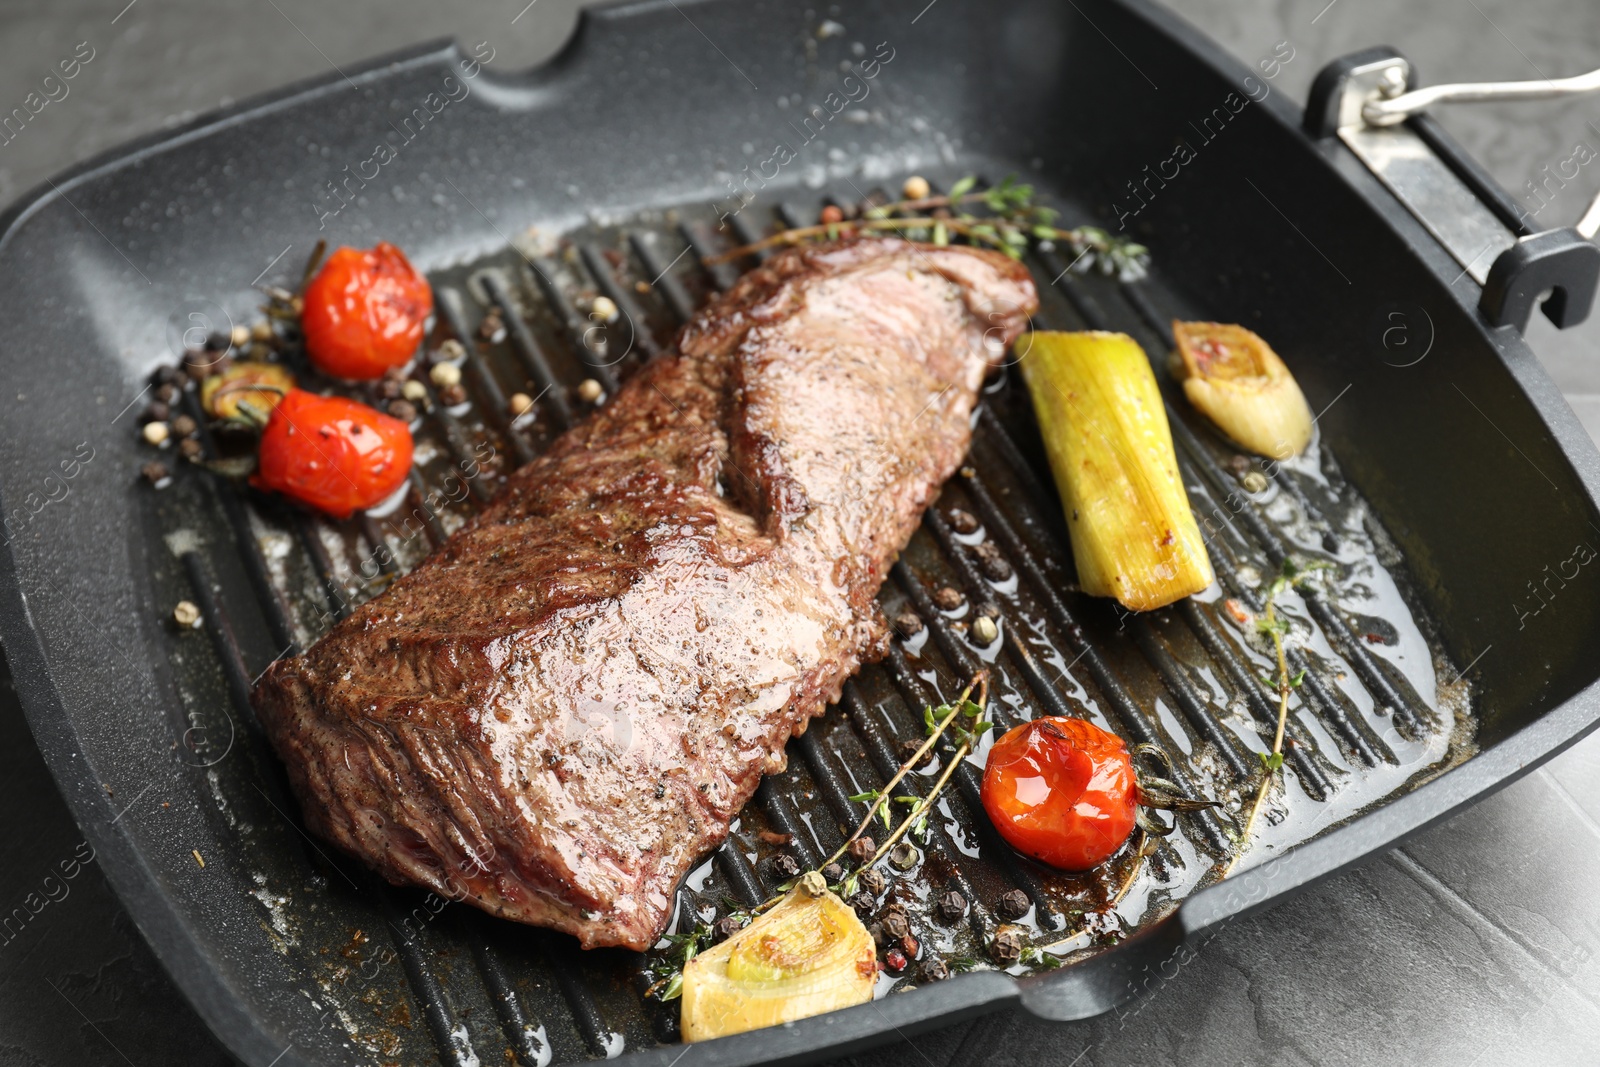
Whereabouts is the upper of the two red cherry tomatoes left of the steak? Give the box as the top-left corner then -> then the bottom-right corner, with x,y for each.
301,242 -> 434,379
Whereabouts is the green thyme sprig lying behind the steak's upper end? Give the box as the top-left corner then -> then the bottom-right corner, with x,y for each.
706,176 -> 1150,282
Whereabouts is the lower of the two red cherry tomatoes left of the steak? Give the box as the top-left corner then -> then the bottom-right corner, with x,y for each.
251,389 -> 411,518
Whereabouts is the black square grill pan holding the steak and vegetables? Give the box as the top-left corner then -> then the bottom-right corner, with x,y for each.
0,0 -> 1600,1065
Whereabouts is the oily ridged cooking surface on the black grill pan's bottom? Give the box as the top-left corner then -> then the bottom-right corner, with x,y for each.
134,177 -> 1464,1064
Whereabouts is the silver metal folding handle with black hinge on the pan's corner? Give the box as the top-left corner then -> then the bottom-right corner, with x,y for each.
1306,48 -> 1600,333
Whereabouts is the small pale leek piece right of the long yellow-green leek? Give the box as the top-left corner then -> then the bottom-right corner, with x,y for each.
1173,322 -> 1312,459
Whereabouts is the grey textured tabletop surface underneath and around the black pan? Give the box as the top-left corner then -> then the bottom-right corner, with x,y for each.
0,0 -> 1600,1067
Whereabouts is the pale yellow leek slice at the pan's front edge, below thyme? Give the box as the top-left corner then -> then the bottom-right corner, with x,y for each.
678,872 -> 877,1041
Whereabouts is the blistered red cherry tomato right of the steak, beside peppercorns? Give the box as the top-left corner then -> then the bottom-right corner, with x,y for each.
982,718 -> 1138,870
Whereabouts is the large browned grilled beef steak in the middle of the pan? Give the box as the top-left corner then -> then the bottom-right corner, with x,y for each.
254,240 -> 1037,949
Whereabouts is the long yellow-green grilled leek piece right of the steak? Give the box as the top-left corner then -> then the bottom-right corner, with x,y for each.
1018,331 -> 1211,611
